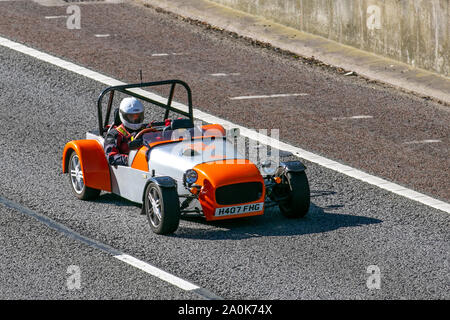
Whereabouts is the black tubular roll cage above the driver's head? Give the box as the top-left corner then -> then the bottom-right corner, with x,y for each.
97,80 -> 194,136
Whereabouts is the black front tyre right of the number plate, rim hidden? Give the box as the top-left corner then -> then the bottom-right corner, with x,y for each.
278,172 -> 310,218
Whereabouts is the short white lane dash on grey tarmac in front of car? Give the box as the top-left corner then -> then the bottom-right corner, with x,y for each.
114,254 -> 200,291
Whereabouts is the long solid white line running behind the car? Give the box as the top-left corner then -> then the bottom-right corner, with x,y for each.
0,37 -> 450,213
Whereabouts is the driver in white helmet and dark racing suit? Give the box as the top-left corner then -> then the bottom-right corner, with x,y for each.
104,97 -> 146,166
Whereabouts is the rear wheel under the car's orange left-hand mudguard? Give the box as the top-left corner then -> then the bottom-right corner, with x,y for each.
68,151 -> 101,200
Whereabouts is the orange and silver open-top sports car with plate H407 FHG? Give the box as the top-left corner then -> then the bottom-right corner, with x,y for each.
62,80 -> 310,234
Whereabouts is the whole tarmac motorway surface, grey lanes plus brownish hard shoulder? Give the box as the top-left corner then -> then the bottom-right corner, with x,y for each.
0,1 -> 450,299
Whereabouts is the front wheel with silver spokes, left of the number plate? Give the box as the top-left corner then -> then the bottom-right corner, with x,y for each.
143,182 -> 181,234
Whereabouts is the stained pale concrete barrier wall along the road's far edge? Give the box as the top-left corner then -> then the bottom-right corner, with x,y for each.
211,0 -> 450,76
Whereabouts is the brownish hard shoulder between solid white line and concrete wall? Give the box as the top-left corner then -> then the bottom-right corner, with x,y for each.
0,1 -> 450,202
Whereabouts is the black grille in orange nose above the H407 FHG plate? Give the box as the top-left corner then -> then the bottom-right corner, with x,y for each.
216,182 -> 262,205
